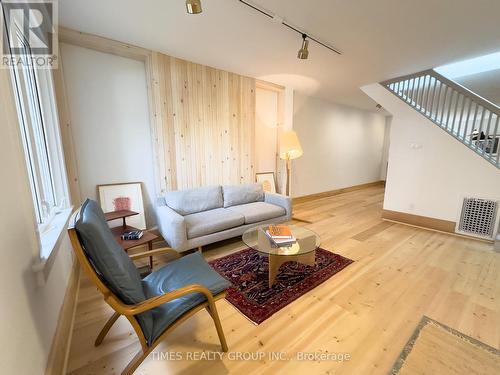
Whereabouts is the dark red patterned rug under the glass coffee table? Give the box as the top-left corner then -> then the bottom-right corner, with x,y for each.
209,249 -> 353,324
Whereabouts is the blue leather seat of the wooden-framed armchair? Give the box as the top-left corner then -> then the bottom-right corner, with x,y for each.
144,252 -> 231,344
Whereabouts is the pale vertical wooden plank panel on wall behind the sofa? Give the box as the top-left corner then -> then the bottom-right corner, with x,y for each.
151,52 -> 255,193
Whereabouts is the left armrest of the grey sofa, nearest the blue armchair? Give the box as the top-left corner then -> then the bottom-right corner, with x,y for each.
156,206 -> 187,251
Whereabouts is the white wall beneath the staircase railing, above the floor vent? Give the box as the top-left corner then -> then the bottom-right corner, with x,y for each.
362,84 -> 500,221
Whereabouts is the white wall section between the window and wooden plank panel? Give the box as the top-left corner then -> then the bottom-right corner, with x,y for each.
60,44 -> 155,227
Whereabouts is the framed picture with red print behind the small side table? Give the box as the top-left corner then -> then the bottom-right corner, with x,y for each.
97,182 -> 146,229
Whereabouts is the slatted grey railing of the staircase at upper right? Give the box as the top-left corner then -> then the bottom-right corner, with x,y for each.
381,69 -> 500,169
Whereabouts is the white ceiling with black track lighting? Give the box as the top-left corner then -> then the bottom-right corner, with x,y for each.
59,0 -> 500,110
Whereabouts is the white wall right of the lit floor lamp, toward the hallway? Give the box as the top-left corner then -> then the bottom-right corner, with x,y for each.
291,93 -> 385,197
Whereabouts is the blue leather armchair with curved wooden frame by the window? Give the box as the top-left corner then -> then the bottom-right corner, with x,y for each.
68,199 -> 230,374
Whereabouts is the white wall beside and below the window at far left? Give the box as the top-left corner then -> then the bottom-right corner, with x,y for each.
0,61 -> 72,375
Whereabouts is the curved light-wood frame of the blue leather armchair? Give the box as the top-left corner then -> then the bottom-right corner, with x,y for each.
68,228 -> 228,375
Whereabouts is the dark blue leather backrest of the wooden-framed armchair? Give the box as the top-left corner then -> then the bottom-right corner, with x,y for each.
75,199 -> 153,342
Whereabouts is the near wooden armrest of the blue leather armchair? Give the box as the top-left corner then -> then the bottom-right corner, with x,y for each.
105,284 -> 214,316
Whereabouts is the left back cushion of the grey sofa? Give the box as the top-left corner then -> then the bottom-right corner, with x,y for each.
165,186 -> 222,216
